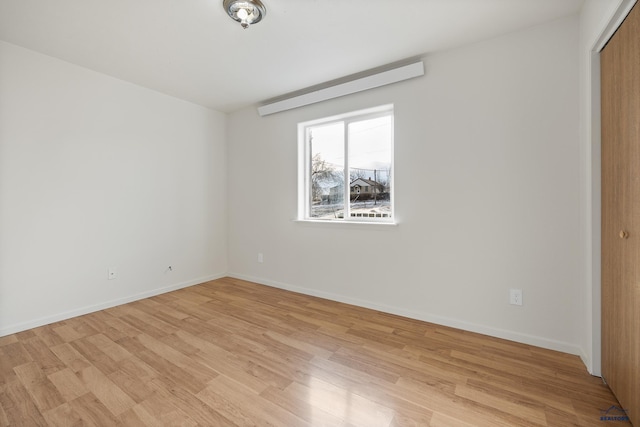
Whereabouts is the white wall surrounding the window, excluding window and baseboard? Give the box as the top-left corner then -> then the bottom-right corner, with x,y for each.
228,17 -> 585,354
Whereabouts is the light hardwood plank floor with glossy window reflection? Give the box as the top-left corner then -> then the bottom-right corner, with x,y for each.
0,278 -> 628,427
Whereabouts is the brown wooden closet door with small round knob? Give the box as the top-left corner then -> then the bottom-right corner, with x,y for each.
600,2 -> 640,426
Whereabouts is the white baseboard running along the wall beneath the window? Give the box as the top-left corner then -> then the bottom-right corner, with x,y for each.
227,272 -> 587,365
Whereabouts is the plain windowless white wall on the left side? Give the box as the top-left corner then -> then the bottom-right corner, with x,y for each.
0,42 -> 227,335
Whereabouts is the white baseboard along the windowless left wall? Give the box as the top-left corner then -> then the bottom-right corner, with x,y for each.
0,274 -> 227,337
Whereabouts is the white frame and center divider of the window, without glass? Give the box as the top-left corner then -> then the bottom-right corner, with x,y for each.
297,104 -> 395,224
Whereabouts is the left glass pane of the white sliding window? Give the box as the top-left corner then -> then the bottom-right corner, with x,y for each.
308,122 -> 344,219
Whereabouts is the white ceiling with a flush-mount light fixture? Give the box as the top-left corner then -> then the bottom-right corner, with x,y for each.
0,0 -> 583,112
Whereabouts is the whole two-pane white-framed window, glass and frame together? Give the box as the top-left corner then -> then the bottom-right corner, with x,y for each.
298,105 -> 393,222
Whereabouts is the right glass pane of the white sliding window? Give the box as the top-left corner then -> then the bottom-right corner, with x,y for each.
348,116 -> 392,218
